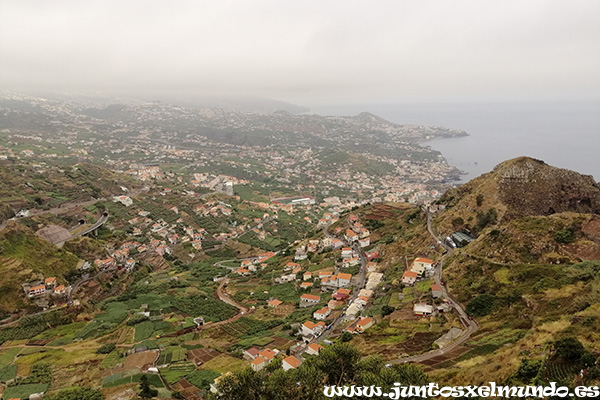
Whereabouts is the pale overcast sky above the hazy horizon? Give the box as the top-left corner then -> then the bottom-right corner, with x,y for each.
0,0 -> 600,106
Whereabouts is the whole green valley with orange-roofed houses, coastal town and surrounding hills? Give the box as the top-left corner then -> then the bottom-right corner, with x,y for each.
0,95 -> 600,400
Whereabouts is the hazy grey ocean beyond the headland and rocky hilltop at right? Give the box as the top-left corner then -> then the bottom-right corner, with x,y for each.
312,102 -> 600,183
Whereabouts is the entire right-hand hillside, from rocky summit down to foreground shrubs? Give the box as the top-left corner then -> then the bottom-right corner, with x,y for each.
422,157 -> 600,383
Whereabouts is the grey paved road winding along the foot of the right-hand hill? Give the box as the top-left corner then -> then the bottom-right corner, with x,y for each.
389,212 -> 479,364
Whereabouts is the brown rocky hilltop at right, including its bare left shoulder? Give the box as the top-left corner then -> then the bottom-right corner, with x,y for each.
436,157 -> 600,231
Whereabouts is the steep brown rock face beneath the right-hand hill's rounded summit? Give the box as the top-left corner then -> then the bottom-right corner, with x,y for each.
492,157 -> 600,219
